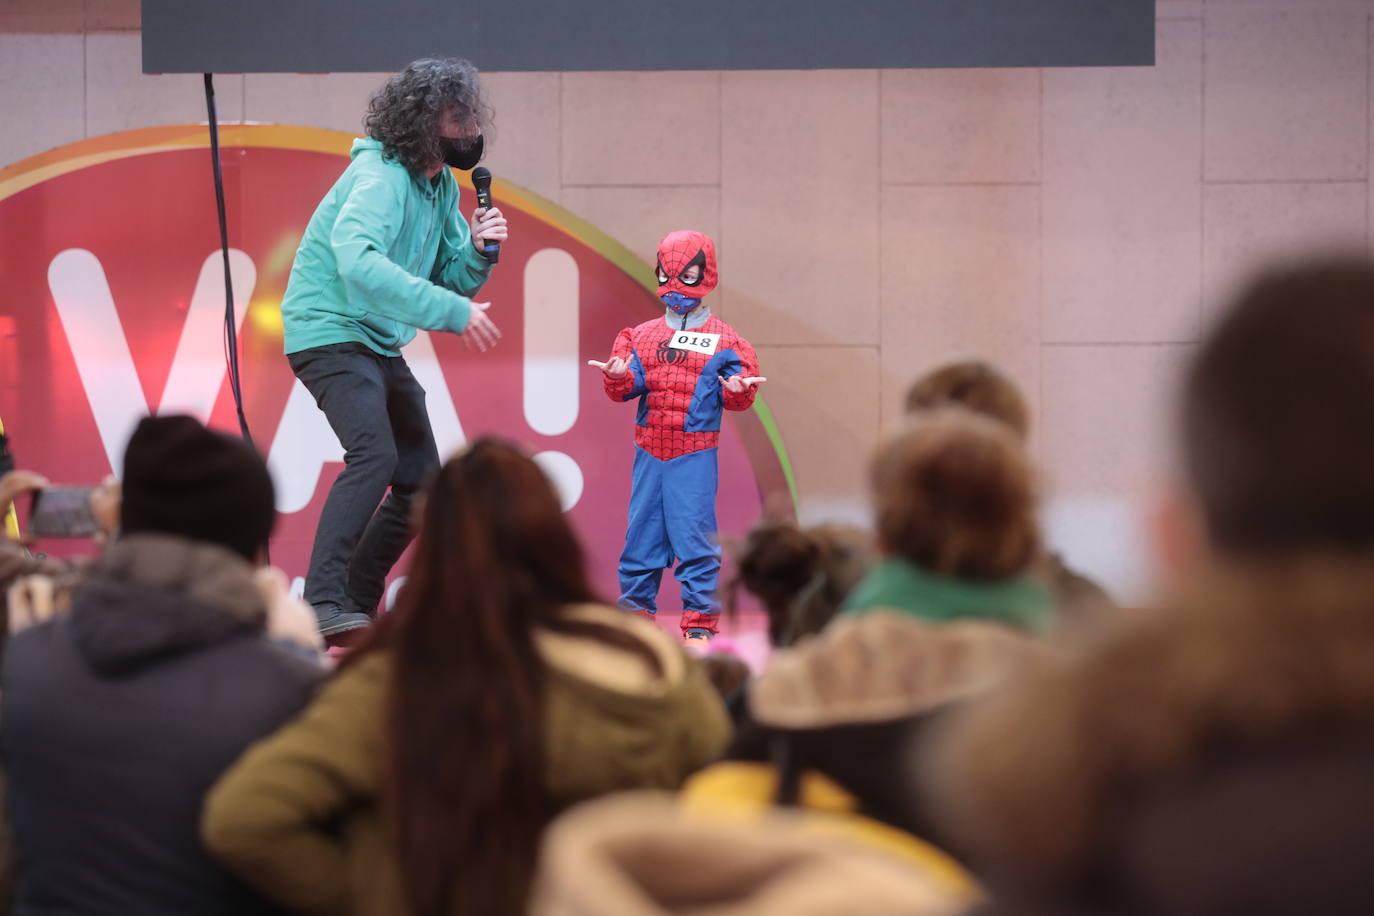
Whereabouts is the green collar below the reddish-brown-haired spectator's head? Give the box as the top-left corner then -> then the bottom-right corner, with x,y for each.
844,558 -> 1054,633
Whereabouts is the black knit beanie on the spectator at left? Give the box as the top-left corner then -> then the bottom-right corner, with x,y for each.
120,416 -> 276,560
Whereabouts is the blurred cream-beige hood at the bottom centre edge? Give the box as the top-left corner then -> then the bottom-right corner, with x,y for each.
529,792 -> 970,916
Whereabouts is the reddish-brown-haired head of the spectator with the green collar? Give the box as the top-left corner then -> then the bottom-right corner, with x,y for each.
871,407 -> 1040,580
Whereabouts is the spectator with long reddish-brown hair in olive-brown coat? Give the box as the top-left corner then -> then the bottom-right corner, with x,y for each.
203,439 -> 728,916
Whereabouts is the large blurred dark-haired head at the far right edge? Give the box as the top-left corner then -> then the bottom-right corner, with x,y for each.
1182,258 -> 1374,556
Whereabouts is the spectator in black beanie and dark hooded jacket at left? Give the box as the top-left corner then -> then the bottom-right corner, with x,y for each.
0,416 -> 320,915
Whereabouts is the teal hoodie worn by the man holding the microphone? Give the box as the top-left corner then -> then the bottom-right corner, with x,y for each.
282,139 -> 491,356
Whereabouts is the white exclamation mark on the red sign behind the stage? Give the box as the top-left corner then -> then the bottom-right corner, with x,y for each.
525,249 -> 583,512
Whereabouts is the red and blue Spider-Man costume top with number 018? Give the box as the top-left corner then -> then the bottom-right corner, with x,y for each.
603,316 -> 758,461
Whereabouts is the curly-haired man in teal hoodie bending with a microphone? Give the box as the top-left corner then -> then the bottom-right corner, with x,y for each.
282,59 -> 507,636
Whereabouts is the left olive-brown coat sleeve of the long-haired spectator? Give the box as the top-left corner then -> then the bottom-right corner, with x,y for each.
201,656 -> 387,913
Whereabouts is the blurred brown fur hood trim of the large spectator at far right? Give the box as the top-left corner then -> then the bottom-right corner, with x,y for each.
930,558 -> 1374,912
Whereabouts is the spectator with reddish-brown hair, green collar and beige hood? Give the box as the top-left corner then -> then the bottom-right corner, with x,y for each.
686,408 -> 1051,878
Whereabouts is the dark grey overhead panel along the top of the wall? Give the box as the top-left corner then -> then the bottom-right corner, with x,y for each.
143,0 -> 1154,73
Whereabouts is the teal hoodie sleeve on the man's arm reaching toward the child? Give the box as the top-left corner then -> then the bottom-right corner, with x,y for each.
330,170 -> 475,334
